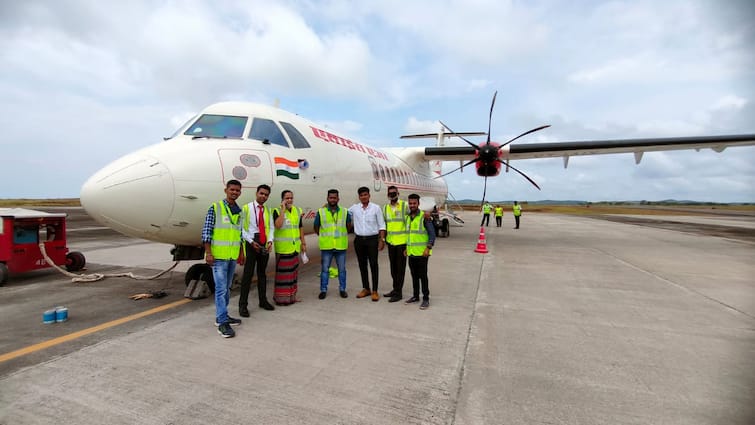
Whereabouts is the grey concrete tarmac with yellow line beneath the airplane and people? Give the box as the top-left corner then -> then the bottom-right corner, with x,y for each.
0,212 -> 755,425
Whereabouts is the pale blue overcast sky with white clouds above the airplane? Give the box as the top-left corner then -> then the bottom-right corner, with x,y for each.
0,0 -> 755,202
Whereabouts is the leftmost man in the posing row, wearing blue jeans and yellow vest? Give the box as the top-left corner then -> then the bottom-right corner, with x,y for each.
202,180 -> 245,338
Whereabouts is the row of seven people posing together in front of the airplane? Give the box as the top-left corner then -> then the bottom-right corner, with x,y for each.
202,180 -> 435,338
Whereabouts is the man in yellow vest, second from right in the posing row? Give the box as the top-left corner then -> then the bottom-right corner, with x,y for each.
383,186 -> 409,303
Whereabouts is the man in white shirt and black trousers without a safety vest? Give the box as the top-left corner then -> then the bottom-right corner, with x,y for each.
349,186 -> 385,301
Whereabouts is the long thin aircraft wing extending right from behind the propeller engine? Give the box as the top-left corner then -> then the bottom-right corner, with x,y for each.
424,134 -> 755,163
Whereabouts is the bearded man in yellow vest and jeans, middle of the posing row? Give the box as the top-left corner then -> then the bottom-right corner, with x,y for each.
315,189 -> 353,300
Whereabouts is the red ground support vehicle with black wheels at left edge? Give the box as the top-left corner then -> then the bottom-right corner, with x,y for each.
0,208 -> 86,285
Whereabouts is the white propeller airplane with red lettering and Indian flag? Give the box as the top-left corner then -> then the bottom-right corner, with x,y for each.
81,96 -> 755,284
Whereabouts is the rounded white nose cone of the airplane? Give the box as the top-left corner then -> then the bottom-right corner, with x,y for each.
80,154 -> 174,238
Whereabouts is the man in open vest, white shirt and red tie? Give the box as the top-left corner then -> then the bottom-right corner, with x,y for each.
239,184 -> 275,317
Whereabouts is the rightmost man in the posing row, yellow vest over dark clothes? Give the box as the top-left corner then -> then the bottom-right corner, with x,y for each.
405,193 -> 435,310
